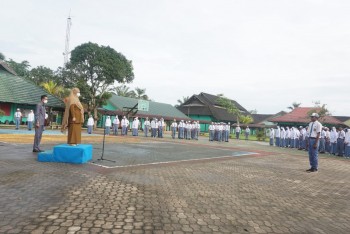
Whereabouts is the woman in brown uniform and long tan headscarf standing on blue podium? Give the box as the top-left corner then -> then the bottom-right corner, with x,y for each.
61,88 -> 84,146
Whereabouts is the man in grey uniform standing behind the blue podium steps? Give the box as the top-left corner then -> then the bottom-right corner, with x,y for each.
33,95 -> 48,152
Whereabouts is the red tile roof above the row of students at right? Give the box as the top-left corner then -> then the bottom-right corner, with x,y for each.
270,107 -> 344,125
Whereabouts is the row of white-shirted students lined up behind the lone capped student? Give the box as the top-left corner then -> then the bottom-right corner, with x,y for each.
270,126 -> 350,158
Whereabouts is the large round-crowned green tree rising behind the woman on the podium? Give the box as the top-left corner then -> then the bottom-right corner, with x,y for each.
66,42 -> 134,126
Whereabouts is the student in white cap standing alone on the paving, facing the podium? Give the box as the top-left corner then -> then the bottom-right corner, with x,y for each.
306,113 -> 322,172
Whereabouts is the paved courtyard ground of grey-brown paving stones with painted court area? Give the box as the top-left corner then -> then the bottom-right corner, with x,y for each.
0,135 -> 350,234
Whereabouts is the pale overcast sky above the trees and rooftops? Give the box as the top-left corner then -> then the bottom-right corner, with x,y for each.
0,0 -> 350,116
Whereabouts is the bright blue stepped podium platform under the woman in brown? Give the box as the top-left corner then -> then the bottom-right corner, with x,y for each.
38,144 -> 92,164
